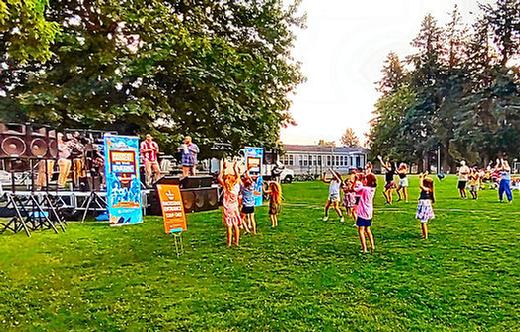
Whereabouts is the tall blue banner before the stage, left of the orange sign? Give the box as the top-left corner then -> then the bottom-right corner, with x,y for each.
104,135 -> 143,226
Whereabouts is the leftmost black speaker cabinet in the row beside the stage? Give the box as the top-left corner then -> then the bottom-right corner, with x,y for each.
0,123 -> 28,158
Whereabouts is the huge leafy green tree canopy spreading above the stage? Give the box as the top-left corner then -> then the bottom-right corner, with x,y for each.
0,0 -> 303,155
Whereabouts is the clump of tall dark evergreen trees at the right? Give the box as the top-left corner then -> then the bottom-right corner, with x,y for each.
368,0 -> 520,170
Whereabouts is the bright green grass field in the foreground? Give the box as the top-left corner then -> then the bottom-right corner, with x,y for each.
0,177 -> 520,331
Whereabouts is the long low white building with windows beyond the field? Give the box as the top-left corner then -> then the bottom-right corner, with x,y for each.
280,145 -> 368,174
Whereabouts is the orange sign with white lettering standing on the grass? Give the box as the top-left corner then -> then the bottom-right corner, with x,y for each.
157,184 -> 187,234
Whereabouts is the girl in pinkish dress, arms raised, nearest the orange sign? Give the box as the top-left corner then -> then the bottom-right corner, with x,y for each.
218,162 -> 240,247
